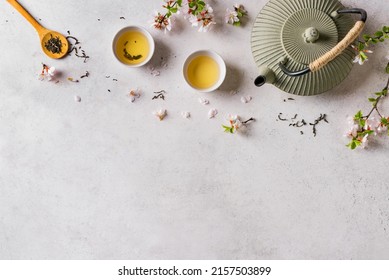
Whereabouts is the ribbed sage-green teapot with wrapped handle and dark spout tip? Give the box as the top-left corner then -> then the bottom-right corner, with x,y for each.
251,0 -> 367,96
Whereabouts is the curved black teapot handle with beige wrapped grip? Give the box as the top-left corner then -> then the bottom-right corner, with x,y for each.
279,8 -> 367,77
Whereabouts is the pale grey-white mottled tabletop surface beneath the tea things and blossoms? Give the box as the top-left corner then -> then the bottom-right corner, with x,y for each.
0,0 -> 389,259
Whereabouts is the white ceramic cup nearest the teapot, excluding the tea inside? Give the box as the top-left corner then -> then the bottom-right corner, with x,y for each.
183,50 -> 227,92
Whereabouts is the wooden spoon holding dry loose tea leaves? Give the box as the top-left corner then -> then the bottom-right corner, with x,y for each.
7,0 -> 69,59
